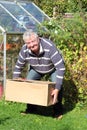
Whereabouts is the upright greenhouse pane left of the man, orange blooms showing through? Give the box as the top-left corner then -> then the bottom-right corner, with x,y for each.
6,34 -> 27,79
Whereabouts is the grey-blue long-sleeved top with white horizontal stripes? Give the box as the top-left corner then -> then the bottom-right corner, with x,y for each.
13,38 -> 65,89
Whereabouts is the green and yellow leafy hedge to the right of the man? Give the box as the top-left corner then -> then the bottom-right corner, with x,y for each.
40,13 -> 87,102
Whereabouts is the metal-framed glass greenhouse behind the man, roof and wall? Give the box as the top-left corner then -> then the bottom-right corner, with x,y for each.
0,1 -> 50,86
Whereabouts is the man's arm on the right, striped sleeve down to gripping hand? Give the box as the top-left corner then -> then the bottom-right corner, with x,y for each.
50,43 -> 65,104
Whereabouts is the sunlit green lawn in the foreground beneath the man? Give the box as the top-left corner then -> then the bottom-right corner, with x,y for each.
0,100 -> 87,130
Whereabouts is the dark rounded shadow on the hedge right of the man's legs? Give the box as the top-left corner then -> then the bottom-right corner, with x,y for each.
63,80 -> 78,113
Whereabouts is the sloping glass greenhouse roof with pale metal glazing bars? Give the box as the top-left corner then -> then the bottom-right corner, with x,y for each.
0,1 -> 50,33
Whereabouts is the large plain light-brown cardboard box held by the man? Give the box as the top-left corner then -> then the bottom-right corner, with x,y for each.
5,79 -> 55,106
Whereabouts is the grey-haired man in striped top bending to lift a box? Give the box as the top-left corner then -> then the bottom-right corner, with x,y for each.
13,30 -> 65,118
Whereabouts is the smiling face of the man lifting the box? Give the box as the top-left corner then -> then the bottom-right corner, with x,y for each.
25,35 -> 39,54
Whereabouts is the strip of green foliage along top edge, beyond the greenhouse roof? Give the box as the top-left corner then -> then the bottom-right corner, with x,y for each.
32,0 -> 87,17
